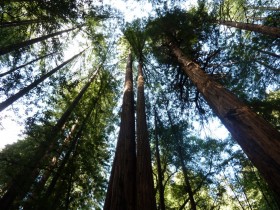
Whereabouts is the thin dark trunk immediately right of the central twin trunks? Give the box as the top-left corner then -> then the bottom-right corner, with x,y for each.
155,108 -> 165,210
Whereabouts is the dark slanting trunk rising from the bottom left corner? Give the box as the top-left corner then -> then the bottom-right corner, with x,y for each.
0,69 -> 97,210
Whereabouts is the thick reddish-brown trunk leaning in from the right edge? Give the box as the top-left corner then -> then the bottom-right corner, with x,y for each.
168,40 -> 280,202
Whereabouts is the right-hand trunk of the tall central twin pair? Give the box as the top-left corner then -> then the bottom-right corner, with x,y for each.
136,58 -> 156,210
